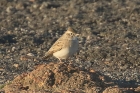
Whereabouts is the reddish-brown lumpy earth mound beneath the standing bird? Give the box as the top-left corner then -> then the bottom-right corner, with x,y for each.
3,62 -> 105,93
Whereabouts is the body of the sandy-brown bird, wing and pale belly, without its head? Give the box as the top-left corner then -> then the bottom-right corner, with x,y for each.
45,34 -> 78,60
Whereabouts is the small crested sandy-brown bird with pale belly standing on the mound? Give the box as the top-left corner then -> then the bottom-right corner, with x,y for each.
43,27 -> 79,62
